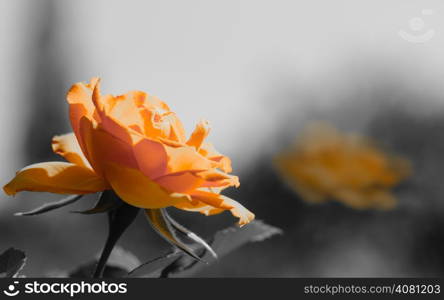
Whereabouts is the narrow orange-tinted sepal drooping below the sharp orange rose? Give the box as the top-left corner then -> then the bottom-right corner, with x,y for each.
145,209 -> 202,261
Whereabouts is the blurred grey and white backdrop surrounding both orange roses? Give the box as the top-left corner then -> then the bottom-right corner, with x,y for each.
0,0 -> 444,277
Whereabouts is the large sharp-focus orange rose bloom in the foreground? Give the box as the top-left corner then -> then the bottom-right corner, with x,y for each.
4,78 -> 254,225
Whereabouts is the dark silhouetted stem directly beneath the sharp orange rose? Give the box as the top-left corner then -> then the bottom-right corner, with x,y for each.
93,202 -> 140,278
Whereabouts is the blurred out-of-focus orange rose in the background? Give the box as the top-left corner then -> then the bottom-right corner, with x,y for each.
275,124 -> 411,209
